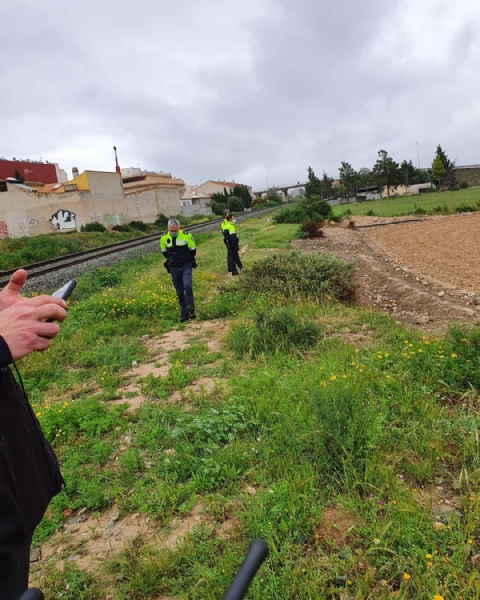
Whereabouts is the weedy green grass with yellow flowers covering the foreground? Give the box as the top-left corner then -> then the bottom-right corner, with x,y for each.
21,219 -> 480,600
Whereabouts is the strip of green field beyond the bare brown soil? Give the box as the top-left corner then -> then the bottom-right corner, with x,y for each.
333,187 -> 480,217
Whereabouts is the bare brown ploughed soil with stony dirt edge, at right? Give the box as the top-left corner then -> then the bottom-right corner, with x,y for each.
293,213 -> 480,332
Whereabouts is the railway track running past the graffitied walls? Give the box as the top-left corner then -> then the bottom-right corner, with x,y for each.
0,207 -> 279,287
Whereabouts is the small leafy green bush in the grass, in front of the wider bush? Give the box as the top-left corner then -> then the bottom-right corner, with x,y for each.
228,308 -> 321,358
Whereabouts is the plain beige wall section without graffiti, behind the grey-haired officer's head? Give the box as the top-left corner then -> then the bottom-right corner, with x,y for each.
125,188 -> 180,223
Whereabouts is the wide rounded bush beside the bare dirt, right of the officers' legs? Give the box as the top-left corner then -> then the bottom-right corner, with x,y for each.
240,250 -> 355,301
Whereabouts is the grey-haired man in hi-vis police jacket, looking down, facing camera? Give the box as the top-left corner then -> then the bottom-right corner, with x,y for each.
160,219 -> 197,323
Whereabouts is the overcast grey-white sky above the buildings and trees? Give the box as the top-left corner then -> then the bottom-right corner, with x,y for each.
0,0 -> 480,189
